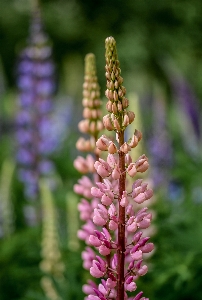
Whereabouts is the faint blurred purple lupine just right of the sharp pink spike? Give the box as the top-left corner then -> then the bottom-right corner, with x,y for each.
143,93 -> 173,188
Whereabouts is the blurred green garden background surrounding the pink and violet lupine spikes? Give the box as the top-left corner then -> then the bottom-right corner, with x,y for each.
0,0 -> 202,300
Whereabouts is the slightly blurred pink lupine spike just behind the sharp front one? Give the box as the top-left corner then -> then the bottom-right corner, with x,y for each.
74,54 -> 105,276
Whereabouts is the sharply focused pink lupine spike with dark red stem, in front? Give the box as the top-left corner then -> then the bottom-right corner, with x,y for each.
84,37 -> 154,300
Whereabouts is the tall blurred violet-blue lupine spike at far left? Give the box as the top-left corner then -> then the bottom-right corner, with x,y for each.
16,8 -> 57,199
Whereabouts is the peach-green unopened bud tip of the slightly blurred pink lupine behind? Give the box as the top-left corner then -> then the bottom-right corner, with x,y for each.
76,53 -> 103,151
